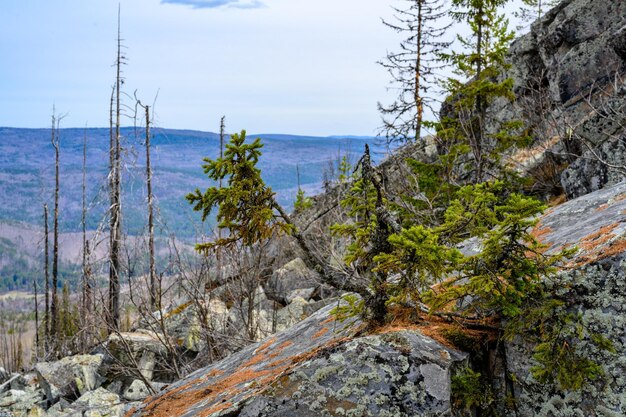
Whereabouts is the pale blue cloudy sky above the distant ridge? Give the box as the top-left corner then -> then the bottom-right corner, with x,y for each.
0,0 -> 528,136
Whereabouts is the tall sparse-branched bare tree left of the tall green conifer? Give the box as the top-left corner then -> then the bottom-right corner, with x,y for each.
378,0 -> 450,143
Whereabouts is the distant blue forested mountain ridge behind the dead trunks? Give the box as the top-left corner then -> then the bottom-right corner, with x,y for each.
0,127 -> 384,238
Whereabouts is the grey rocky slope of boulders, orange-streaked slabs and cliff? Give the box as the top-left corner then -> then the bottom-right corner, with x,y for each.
0,0 -> 626,417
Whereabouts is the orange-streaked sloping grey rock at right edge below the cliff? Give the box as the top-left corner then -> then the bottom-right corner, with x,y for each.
507,183 -> 626,417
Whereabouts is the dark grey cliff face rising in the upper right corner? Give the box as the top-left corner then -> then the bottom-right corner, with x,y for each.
499,0 -> 626,198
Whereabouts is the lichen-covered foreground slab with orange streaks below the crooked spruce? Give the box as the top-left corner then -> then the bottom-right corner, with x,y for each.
129,306 -> 466,417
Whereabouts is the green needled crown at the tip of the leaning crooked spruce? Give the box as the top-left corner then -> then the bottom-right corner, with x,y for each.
186,130 -> 288,253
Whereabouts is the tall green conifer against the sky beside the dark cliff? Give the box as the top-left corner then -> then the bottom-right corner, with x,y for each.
435,0 -> 530,184
